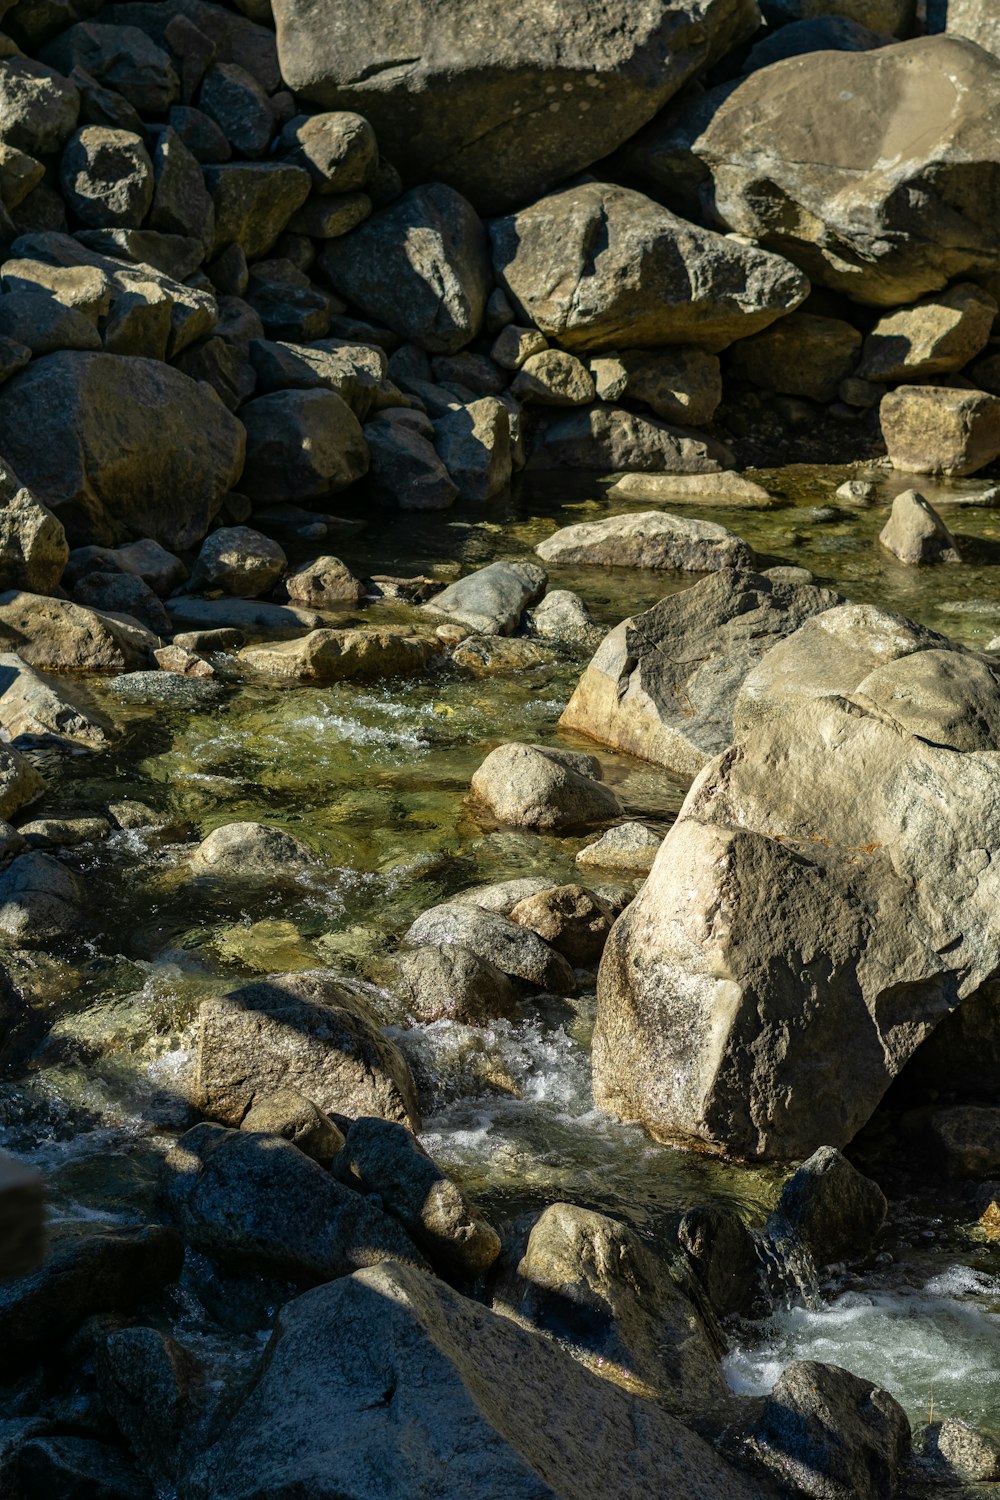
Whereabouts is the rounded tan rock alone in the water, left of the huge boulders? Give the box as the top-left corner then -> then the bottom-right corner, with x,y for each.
469,744 -> 622,833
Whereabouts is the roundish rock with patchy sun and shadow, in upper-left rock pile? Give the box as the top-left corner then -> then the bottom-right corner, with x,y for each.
58,125 -> 153,230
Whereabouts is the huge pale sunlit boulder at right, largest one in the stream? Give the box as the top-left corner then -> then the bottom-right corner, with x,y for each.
594,606 -> 1000,1158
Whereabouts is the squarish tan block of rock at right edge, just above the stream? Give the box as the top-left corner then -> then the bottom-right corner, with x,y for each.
881,377 -> 1000,476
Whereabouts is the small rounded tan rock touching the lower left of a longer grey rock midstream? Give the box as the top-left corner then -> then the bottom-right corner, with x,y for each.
390,944 -> 520,1026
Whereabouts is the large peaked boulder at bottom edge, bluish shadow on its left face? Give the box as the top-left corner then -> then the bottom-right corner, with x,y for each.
184,1266 -> 751,1500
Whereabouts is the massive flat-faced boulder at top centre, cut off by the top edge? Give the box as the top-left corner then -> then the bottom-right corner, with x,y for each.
273,0 -> 759,212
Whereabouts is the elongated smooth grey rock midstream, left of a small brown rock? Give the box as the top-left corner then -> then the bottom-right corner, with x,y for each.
405,902 -> 576,995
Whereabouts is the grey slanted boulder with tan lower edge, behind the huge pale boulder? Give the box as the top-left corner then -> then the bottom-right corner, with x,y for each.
559,569 -> 840,777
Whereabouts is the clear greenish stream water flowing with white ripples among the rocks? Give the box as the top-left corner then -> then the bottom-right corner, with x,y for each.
0,470 -> 1000,1425
